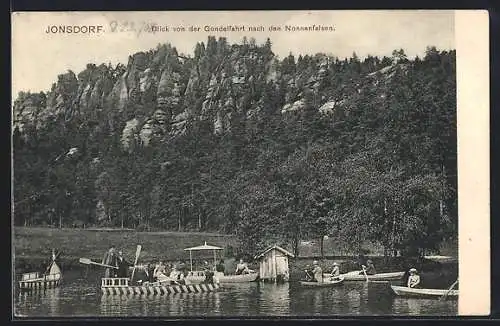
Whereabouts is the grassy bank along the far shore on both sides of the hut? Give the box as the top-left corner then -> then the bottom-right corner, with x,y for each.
13,227 -> 457,287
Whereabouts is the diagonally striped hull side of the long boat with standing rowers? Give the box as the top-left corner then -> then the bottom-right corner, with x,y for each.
101,284 -> 220,296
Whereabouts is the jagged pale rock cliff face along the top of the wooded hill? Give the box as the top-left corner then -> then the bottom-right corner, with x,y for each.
14,38 -> 402,150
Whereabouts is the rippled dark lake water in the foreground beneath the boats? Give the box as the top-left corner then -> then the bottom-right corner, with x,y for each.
14,271 -> 458,318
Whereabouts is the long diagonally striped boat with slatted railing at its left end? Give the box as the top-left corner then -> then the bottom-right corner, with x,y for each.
101,277 -> 220,296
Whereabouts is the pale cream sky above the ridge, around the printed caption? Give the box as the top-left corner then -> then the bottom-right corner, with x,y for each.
12,10 -> 455,97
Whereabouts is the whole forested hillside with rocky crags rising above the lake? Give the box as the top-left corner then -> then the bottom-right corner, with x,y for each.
13,37 -> 457,258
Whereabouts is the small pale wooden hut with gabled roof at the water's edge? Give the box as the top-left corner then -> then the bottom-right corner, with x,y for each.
255,245 -> 295,282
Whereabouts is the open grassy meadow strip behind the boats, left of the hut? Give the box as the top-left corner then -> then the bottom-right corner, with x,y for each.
13,227 -> 237,269
